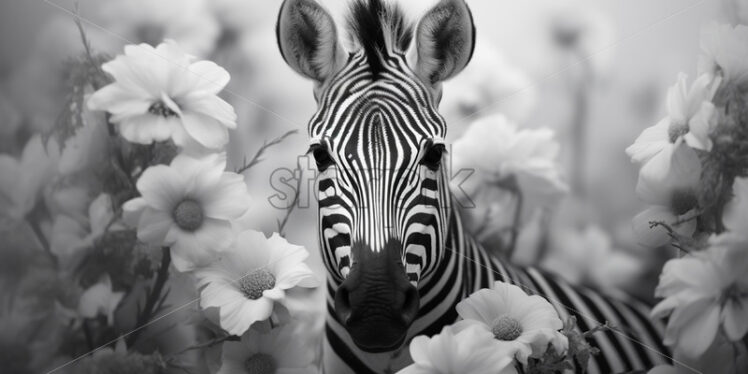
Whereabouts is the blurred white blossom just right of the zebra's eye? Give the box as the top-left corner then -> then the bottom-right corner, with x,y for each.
452,114 -> 567,235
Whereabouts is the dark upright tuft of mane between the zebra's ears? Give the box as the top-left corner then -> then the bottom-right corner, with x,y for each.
348,0 -> 413,79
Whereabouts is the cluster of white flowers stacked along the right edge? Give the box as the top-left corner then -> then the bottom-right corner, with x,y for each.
626,25 -> 748,372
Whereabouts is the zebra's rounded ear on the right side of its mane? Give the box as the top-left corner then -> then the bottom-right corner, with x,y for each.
411,0 -> 475,86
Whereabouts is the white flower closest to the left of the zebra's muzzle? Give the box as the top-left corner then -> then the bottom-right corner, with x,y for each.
195,230 -> 318,335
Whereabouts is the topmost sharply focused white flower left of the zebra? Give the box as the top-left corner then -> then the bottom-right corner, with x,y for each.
88,40 -> 236,151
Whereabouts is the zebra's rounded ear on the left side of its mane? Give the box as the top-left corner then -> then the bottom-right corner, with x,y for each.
275,0 -> 345,83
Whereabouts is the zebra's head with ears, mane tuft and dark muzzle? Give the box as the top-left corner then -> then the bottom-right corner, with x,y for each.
276,0 -> 474,352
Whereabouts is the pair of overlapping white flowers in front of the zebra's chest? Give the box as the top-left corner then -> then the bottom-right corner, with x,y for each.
398,282 -> 569,374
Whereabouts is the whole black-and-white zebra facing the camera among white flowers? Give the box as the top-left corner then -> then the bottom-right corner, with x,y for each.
276,0 -> 669,374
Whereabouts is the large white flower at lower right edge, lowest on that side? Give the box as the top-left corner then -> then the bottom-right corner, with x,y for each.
652,232 -> 748,358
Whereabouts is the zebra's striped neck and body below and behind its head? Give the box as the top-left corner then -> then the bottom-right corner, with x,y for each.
323,200 -> 670,374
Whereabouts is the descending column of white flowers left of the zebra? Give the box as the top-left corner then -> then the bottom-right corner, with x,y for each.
86,41 -> 318,373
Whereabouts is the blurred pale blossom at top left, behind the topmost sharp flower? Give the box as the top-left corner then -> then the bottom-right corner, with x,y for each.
96,0 -> 219,56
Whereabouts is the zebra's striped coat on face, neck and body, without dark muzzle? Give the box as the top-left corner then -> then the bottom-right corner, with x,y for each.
296,1 -> 668,374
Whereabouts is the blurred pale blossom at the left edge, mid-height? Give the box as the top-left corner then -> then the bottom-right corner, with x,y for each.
0,135 -> 59,226
